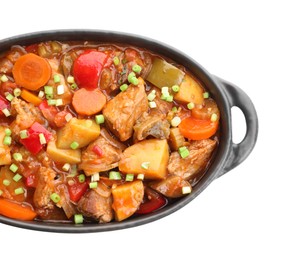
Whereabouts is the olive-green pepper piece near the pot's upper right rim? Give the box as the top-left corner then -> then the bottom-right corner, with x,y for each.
147,58 -> 185,88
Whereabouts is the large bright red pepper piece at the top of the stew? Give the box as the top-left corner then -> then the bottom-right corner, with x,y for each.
73,50 -> 108,89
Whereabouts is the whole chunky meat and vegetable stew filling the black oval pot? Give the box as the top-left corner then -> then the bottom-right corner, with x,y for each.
0,41 -> 220,224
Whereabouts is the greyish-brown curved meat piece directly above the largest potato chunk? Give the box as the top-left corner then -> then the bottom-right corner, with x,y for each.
134,111 -> 170,141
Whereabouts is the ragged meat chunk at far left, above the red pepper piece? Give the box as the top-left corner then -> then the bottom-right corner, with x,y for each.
11,98 -> 44,133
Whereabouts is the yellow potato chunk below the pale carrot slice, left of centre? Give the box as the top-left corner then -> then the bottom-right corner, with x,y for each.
56,117 -> 100,149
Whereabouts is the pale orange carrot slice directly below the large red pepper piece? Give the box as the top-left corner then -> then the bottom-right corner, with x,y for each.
72,88 -> 106,116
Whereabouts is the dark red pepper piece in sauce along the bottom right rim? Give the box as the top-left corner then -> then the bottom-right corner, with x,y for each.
136,188 -> 168,214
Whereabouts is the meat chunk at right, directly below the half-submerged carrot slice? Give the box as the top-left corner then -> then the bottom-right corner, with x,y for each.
168,139 -> 216,180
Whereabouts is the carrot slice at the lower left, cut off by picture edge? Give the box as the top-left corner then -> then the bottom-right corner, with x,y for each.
0,199 -> 37,220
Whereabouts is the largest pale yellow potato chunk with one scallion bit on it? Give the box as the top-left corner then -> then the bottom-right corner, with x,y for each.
119,139 -> 169,179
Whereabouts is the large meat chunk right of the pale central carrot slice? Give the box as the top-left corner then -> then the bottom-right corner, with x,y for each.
103,78 -> 148,141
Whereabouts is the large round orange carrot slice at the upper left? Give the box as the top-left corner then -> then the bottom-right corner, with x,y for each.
12,53 -> 51,90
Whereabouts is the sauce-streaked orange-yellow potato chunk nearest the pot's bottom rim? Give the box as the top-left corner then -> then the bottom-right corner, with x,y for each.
112,180 -> 144,221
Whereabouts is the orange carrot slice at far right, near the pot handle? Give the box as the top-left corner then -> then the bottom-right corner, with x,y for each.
178,117 -> 218,140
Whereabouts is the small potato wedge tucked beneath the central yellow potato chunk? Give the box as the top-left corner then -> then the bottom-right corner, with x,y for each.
47,141 -> 81,164
